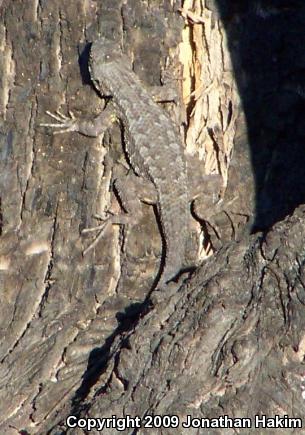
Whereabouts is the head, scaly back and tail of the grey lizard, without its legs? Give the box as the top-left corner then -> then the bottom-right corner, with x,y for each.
89,39 -> 190,284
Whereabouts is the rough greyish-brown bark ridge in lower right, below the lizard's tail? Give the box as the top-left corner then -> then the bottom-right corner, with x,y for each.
52,207 -> 305,434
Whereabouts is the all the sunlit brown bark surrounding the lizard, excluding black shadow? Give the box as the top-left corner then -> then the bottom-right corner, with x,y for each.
0,0 -> 305,434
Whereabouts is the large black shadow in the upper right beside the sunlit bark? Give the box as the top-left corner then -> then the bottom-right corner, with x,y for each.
217,0 -> 305,231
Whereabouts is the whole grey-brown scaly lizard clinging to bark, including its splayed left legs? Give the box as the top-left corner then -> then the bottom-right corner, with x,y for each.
41,38 -> 221,288
